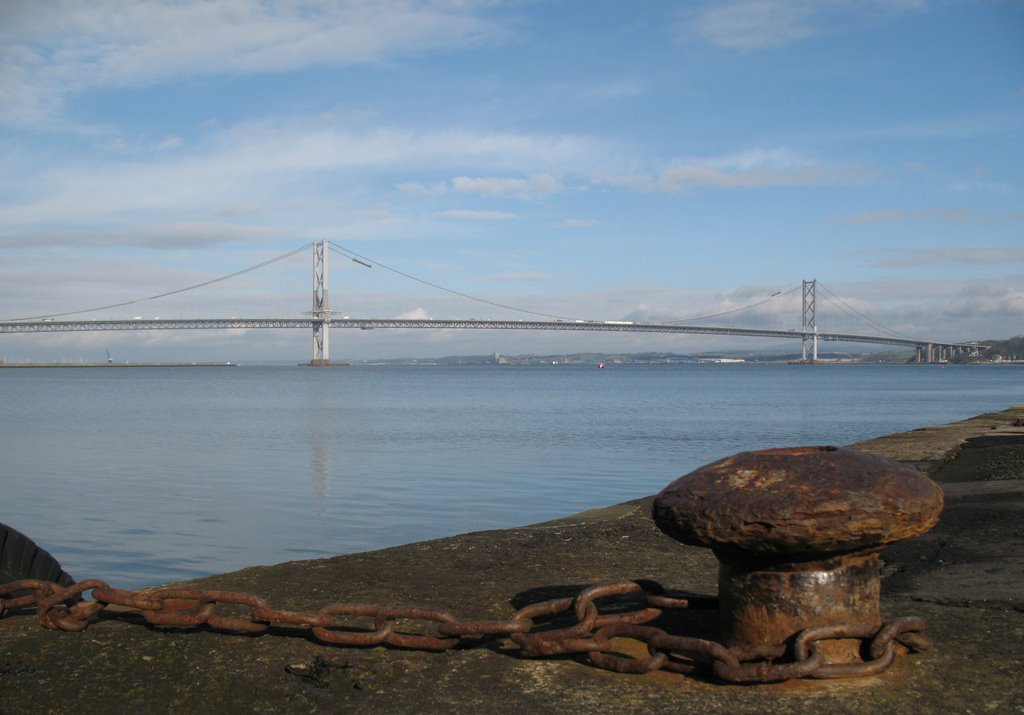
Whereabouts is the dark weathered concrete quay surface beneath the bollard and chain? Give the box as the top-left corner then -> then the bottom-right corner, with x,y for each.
0,406 -> 1024,715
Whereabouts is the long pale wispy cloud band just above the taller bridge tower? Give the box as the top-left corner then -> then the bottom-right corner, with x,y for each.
0,122 -> 600,226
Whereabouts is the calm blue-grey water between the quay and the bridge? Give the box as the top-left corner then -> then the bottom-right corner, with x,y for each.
0,365 -> 1024,588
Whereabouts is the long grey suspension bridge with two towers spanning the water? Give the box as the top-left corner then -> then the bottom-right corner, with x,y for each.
0,241 -> 980,366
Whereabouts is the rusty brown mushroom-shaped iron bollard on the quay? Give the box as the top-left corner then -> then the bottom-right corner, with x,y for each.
654,447 -> 942,663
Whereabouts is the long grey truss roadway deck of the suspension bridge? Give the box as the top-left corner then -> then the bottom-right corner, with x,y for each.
0,317 -> 978,352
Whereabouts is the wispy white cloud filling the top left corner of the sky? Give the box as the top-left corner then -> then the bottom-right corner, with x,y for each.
0,0 -> 501,123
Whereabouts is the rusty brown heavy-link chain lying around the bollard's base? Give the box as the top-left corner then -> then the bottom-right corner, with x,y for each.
0,579 -> 931,683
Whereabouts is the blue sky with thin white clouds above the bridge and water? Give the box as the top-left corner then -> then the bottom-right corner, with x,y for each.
0,0 -> 1024,361
